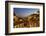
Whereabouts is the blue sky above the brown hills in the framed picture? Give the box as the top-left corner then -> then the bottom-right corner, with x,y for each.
14,8 -> 39,17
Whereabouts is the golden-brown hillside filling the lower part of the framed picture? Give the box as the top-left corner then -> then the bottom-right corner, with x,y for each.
14,14 -> 40,28
